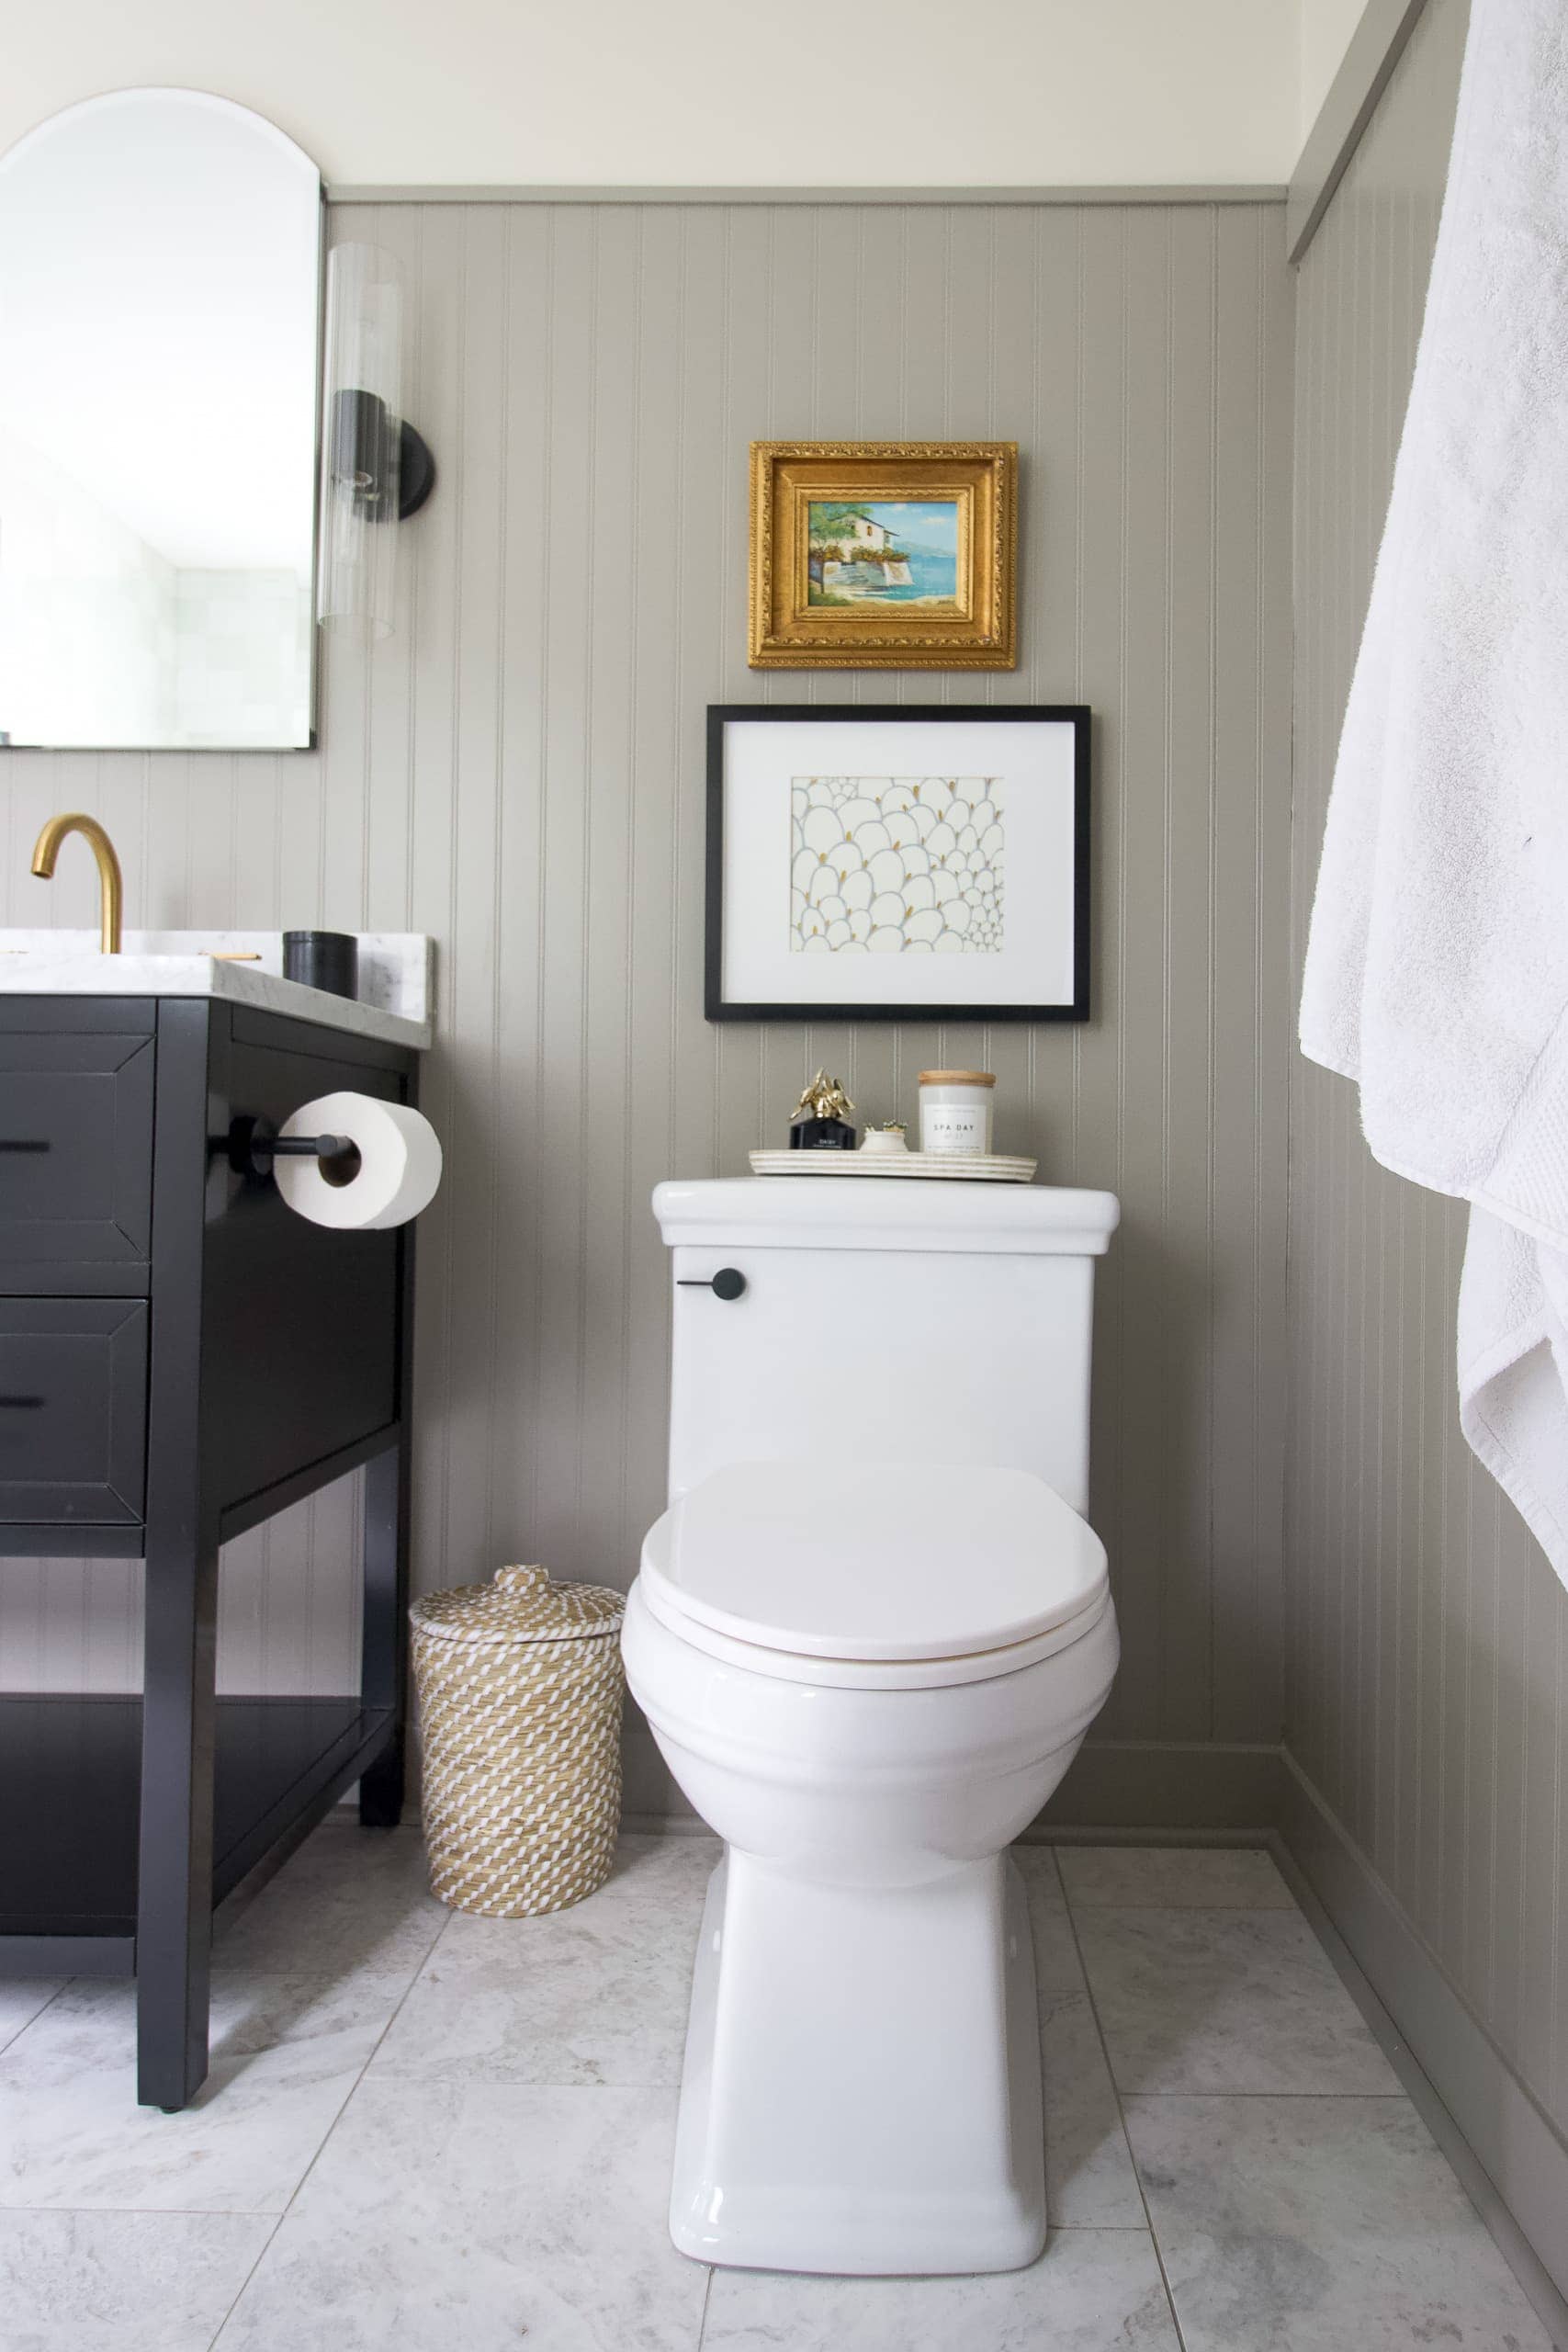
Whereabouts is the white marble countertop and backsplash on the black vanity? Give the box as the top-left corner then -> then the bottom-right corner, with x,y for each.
0,932 -> 434,1051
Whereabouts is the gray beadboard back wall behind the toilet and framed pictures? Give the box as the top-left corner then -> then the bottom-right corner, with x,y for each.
0,202 -> 1291,1804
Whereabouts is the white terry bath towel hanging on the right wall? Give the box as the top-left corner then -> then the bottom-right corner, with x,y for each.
1300,0 -> 1568,1583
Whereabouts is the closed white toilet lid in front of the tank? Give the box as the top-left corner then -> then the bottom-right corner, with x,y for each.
642,1461 -> 1105,1660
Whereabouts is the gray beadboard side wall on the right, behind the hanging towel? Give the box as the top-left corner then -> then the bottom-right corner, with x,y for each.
1286,0 -> 1568,2182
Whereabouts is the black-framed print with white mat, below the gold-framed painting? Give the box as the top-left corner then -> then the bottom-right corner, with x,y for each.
707,703 -> 1089,1021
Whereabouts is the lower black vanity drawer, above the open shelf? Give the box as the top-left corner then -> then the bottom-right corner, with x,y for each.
0,1298 -> 148,1526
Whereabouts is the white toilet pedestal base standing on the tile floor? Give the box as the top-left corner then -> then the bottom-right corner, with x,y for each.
670,1849 -> 1046,2277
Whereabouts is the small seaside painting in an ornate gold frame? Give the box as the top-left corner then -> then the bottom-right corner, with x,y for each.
750,442 -> 1018,671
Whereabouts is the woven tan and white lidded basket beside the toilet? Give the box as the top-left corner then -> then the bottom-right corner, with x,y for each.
409,1566 -> 626,1919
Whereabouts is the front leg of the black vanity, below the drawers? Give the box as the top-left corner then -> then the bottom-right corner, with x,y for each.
136,1536 -> 219,2114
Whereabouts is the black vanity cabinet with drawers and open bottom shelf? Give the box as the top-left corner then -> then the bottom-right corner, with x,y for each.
0,995 -> 419,2108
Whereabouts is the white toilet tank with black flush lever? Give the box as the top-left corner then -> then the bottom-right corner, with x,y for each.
653,1176 -> 1119,1512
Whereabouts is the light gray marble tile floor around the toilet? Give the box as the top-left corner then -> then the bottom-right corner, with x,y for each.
0,1823 -> 1550,2352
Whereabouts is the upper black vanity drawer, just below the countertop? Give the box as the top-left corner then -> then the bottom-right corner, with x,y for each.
0,997 -> 152,1289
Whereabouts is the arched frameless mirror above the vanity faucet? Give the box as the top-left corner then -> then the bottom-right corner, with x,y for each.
0,89 -> 322,751
